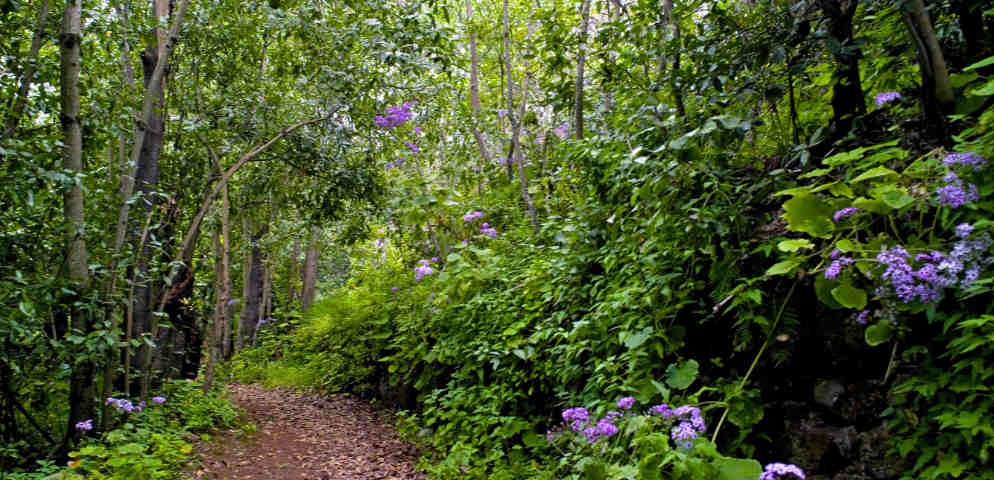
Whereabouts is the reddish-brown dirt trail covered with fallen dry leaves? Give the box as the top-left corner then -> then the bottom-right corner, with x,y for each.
188,385 -> 425,480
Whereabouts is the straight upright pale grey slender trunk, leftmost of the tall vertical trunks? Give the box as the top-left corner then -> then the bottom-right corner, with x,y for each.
59,0 -> 96,446
